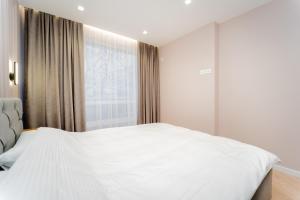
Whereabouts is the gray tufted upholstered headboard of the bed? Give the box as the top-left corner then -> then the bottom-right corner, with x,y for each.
0,98 -> 23,154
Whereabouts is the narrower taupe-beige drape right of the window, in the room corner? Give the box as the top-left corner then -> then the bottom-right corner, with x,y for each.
138,42 -> 160,124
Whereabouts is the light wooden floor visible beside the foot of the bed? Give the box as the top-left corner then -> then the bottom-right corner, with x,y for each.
272,170 -> 300,200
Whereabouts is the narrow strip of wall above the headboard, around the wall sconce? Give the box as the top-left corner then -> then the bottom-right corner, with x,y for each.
0,0 -> 21,97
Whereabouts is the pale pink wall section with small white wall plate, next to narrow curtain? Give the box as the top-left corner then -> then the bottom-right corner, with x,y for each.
159,24 -> 217,134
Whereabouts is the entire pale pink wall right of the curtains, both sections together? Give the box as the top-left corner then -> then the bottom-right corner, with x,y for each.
160,0 -> 300,170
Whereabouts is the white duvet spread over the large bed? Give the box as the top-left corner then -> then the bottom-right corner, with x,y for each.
0,124 -> 278,200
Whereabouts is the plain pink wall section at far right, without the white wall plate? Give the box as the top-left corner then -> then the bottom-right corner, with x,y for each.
218,0 -> 300,170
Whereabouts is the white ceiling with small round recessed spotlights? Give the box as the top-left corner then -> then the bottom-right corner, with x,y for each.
19,0 -> 271,46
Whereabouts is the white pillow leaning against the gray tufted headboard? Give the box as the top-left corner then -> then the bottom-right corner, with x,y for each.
0,131 -> 36,170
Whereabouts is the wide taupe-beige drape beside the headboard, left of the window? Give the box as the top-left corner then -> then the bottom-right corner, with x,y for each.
24,9 -> 85,131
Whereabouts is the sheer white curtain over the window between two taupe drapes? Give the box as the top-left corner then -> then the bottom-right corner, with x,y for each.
84,26 -> 138,130
